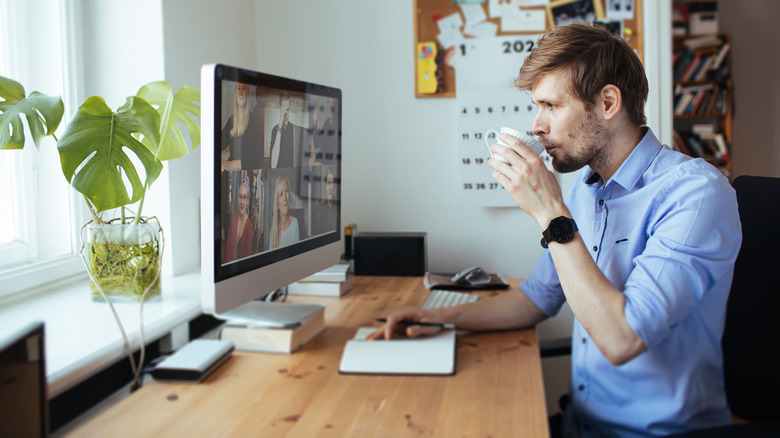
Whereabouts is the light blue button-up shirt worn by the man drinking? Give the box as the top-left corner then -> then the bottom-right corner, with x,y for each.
520,129 -> 742,437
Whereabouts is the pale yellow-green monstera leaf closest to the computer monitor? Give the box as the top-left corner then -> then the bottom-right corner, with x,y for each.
136,81 -> 200,161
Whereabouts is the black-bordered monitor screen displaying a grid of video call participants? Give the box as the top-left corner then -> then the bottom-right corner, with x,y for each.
214,69 -> 341,278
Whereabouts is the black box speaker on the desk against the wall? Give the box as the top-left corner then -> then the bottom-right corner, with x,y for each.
354,233 -> 428,277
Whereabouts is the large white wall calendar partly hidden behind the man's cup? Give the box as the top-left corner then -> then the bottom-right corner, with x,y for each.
455,35 -> 551,207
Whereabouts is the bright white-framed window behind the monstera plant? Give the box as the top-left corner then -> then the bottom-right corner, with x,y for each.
0,0 -> 83,296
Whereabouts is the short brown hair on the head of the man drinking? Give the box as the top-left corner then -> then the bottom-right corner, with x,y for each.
515,23 -> 648,126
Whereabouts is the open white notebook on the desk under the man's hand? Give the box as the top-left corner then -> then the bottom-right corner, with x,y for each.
339,327 -> 456,375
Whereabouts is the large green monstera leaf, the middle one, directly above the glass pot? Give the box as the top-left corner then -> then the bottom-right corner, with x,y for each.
57,96 -> 162,212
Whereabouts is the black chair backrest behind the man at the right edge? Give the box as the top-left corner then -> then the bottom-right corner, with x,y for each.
722,176 -> 780,421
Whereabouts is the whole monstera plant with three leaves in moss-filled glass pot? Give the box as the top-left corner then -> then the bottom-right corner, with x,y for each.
0,77 -> 200,300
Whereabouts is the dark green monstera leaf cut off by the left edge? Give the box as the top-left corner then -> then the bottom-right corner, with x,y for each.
0,76 -> 64,149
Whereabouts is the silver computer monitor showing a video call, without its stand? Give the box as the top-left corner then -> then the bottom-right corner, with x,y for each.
201,64 -> 341,314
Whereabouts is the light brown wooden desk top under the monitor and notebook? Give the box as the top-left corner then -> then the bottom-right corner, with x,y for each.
74,277 -> 548,438
